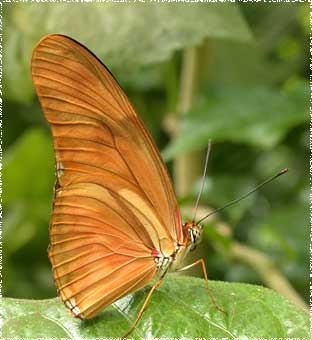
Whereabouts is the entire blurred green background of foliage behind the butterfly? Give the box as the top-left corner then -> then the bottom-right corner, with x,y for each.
3,3 -> 309,308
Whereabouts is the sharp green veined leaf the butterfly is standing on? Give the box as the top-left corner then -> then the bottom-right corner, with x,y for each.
3,274 -> 309,339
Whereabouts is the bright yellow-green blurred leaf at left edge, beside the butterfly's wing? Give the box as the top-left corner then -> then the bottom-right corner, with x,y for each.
3,129 -> 54,255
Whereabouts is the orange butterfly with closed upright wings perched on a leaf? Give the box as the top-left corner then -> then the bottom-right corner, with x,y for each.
32,35 -> 219,335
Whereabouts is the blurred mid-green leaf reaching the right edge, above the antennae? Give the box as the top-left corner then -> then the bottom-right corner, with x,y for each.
163,85 -> 309,160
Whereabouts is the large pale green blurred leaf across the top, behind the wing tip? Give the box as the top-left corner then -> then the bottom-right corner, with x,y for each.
4,3 -> 251,100
